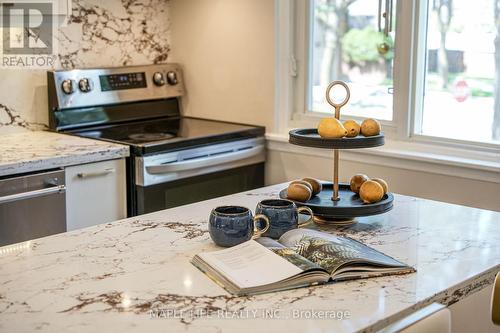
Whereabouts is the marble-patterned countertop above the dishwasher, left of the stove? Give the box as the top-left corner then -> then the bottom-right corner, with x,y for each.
0,131 -> 129,176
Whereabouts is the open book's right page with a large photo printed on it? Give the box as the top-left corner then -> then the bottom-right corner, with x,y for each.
279,229 -> 406,274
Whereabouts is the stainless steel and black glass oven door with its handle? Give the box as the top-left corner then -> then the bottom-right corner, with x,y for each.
132,138 -> 265,215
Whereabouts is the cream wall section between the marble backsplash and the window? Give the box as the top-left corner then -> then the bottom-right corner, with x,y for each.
169,0 -> 275,128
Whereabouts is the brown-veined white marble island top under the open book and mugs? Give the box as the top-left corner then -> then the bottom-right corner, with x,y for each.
0,184 -> 500,333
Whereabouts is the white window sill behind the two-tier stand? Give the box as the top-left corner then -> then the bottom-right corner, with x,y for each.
266,133 -> 500,183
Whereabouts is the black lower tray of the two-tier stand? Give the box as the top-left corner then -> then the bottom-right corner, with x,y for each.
279,183 -> 394,219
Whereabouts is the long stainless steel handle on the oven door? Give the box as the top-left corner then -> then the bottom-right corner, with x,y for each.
146,145 -> 265,174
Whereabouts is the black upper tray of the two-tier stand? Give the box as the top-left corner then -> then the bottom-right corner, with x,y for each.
288,128 -> 385,149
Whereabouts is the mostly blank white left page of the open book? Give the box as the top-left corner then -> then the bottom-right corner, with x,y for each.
198,240 -> 302,289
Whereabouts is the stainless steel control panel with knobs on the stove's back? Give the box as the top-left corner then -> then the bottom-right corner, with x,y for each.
47,64 -> 184,110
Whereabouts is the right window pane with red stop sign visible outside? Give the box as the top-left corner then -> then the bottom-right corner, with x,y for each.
416,0 -> 500,143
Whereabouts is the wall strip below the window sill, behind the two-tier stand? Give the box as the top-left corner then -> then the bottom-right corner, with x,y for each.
266,150 -> 500,211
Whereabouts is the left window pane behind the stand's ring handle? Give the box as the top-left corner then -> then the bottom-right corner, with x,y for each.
309,0 -> 395,120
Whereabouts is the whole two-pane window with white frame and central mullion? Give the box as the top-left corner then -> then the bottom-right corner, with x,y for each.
292,0 -> 500,145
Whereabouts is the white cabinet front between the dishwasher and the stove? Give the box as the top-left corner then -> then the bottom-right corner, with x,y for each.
65,159 -> 127,231
